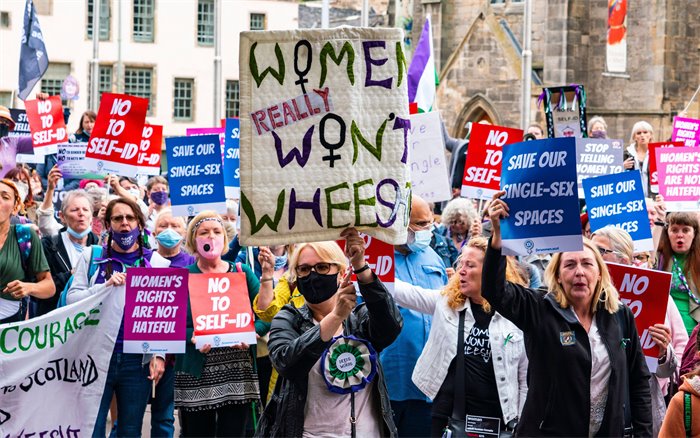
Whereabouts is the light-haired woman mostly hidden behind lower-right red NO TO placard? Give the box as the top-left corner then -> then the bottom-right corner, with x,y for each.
592,225 -> 688,436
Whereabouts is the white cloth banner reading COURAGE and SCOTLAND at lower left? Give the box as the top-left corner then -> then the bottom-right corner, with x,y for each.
0,285 -> 124,437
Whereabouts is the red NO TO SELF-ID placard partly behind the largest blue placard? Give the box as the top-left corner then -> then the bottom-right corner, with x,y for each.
462,124 -> 523,199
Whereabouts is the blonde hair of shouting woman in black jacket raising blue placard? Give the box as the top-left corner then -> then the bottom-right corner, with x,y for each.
544,238 -> 620,313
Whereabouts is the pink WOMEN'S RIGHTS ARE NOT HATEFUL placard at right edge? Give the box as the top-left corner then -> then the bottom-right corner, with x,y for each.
656,147 -> 700,211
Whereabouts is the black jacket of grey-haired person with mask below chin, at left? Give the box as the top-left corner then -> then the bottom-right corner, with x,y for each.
36,228 -> 99,316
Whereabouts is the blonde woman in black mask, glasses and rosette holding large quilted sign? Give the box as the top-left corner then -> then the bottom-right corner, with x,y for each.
256,228 -> 403,437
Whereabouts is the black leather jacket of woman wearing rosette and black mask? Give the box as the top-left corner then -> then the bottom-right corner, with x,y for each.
256,276 -> 403,437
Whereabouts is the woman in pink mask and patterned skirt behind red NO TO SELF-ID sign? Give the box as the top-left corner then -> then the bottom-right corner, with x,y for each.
175,211 -> 269,437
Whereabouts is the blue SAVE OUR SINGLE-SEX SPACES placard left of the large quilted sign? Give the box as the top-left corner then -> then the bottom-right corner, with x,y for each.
165,135 -> 226,216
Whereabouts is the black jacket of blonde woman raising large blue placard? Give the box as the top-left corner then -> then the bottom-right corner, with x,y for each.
482,245 -> 652,437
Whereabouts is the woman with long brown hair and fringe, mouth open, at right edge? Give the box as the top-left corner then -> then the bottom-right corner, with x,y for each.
657,212 -> 700,334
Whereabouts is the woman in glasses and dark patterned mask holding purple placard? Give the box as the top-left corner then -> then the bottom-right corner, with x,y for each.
66,198 -> 165,436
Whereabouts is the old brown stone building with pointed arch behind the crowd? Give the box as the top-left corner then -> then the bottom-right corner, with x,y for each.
412,0 -> 700,142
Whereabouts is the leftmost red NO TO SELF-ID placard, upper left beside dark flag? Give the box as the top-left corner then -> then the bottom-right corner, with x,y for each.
24,96 -> 68,156
